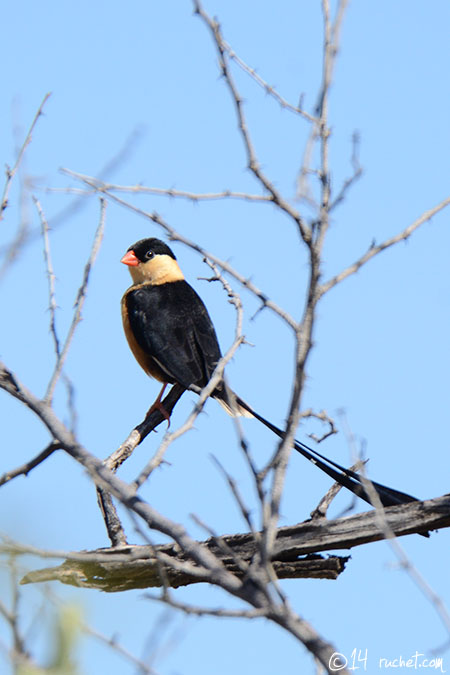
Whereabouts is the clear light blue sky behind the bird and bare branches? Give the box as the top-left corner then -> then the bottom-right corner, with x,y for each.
0,0 -> 450,675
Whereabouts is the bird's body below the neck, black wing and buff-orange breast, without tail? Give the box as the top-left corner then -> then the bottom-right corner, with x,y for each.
126,281 -> 221,388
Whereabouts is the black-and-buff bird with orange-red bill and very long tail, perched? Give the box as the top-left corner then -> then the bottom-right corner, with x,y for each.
120,237 -> 418,506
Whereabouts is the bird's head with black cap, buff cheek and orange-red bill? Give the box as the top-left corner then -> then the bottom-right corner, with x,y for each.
120,237 -> 184,285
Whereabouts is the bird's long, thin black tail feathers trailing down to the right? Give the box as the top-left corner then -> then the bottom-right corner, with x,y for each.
236,396 -> 418,506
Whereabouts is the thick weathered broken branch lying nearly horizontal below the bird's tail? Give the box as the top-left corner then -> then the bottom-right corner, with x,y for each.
22,495 -> 450,592
